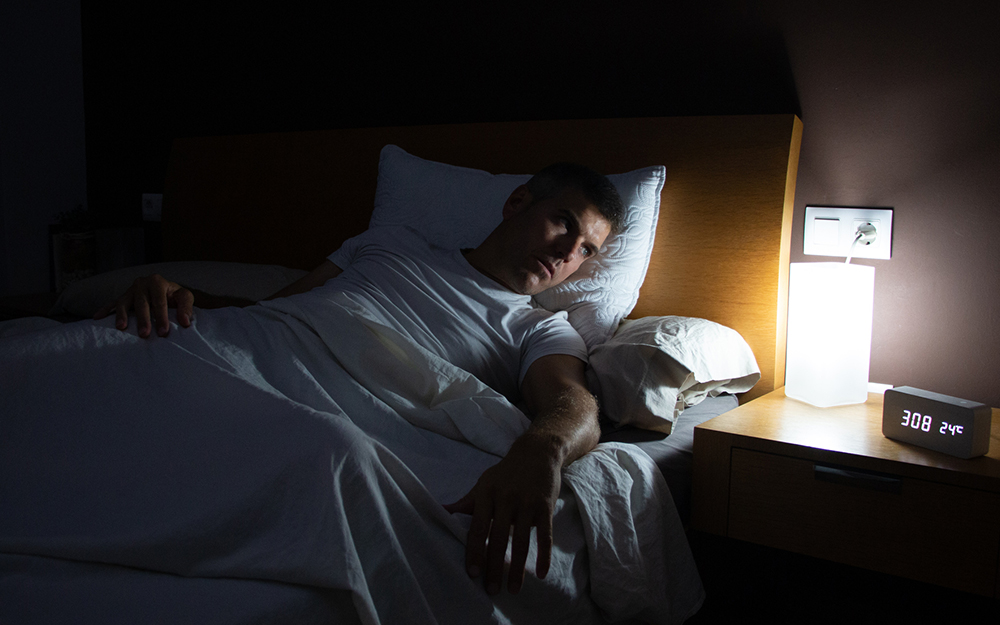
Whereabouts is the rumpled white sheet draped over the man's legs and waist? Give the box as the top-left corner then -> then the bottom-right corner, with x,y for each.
0,294 -> 703,624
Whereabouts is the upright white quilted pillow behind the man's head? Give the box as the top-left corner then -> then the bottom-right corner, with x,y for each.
369,145 -> 666,349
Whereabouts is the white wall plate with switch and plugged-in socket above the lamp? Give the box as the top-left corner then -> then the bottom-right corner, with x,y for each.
802,206 -> 892,260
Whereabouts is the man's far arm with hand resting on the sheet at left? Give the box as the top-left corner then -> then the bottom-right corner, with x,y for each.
94,260 -> 341,338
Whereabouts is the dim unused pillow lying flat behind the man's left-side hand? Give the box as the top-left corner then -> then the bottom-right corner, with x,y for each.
50,261 -> 308,317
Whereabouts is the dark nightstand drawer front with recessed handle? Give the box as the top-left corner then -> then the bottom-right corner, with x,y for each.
728,448 -> 1000,596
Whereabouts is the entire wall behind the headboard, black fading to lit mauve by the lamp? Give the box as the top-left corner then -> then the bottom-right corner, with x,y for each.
0,0 -> 1000,406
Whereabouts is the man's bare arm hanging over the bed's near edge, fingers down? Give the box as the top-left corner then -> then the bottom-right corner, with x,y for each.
445,355 -> 600,594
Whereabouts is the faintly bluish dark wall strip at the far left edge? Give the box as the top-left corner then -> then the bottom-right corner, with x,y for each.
0,0 -> 87,296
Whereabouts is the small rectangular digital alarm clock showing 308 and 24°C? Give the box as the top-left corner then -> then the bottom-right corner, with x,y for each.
882,386 -> 992,458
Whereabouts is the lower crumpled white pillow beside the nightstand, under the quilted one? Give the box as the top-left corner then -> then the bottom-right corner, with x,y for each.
588,317 -> 760,434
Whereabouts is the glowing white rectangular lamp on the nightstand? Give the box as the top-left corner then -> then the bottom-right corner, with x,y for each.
785,263 -> 875,408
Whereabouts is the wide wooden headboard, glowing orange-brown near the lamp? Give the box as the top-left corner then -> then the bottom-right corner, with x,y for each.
162,115 -> 802,401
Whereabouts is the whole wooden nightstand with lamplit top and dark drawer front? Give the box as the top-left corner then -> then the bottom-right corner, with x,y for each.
691,389 -> 1000,597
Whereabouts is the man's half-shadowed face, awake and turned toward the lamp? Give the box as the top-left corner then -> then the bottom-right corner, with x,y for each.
497,187 -> 611,295
